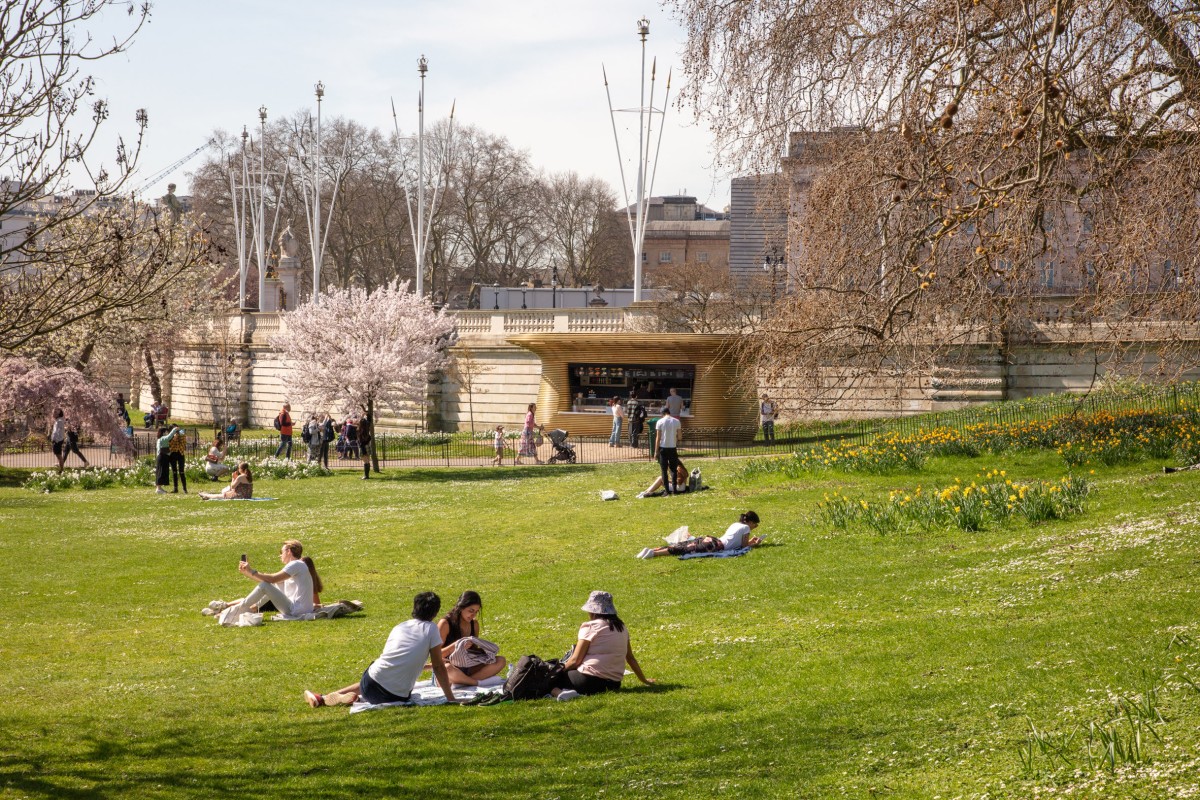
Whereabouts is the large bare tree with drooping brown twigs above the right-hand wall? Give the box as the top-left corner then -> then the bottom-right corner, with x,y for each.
672,0 -> 1200,398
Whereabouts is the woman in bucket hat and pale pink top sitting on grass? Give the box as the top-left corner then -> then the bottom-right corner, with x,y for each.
551,591 -> 654,700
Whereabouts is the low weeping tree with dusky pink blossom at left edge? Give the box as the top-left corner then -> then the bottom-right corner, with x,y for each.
0,357 -> 130,446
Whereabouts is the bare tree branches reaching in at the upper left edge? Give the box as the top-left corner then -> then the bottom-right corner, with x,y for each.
0,0 -> 172,351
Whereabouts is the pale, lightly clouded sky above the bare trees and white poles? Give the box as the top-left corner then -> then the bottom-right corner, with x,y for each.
88,0 -> 730,210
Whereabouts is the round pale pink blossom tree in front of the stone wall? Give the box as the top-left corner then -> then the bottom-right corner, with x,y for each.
271,281 -> 454,471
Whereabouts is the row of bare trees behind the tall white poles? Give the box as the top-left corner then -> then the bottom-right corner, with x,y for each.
192,113 -> 630,303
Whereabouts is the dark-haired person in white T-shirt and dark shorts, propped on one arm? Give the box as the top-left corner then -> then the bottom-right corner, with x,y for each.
304,591 -> 458,709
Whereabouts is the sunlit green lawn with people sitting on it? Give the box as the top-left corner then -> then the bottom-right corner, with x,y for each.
0,453 -> 1200,800
